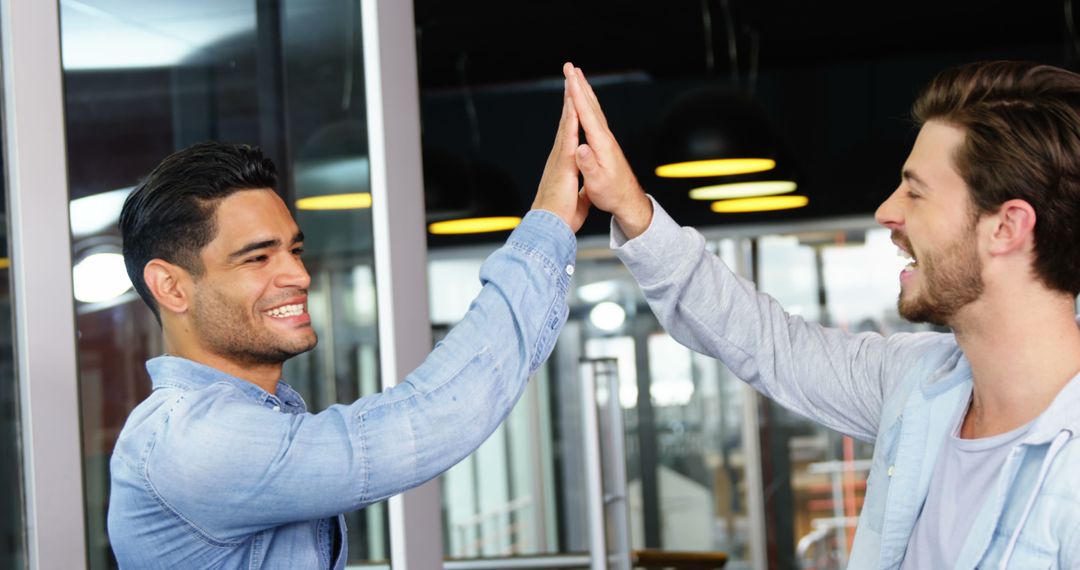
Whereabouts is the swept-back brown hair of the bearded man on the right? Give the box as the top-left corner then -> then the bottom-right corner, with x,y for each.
912,62 -> 1080,296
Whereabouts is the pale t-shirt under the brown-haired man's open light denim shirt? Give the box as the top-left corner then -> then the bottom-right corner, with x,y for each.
901,403 -> 1035,570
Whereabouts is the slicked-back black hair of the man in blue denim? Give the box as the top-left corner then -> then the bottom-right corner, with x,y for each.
120,141 -> 278,323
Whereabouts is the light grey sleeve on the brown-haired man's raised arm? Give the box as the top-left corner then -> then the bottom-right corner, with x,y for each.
611,196 -> 937,440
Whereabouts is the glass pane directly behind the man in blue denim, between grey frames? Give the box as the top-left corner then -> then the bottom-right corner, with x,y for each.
60,0 -> 389,568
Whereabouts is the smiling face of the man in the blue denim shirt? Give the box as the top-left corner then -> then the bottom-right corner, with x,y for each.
190,190 -> 316,366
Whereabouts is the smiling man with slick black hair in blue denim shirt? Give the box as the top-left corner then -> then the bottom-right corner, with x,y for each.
108,87 -> 589,569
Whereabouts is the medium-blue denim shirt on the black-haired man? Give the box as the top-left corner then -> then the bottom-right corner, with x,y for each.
108,211 -> 576,569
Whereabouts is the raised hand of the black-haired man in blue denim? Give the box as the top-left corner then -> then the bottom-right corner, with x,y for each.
532,81 -> 589,232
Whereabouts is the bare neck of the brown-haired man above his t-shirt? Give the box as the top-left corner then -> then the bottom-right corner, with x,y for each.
953,288 -> 1080,438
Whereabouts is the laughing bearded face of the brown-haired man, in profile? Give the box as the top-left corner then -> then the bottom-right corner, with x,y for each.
876,121 -> 984,325
